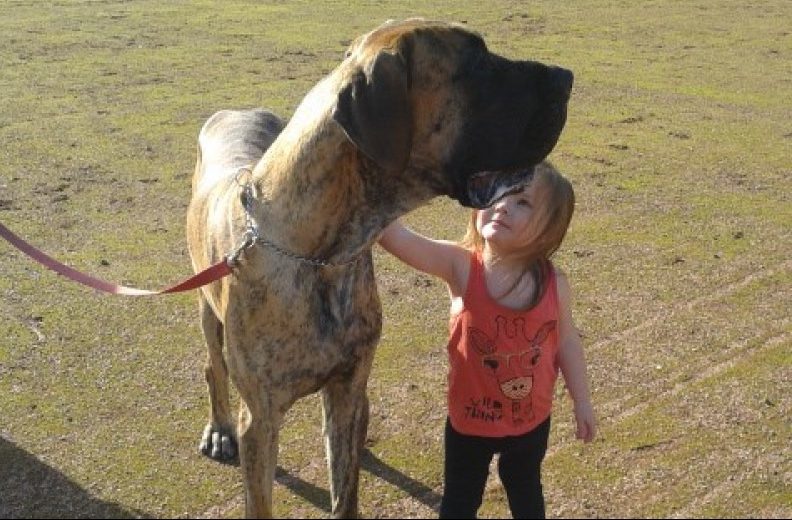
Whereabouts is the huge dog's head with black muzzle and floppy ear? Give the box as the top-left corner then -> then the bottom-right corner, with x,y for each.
333,19 -> 573,208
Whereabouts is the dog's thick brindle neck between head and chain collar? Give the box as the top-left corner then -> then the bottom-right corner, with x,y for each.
248,87 -> 437,263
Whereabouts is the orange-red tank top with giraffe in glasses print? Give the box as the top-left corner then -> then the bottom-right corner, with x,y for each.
448,253 -> 558,437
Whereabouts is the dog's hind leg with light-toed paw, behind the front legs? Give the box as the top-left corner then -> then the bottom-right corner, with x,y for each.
199,293 -> 237,463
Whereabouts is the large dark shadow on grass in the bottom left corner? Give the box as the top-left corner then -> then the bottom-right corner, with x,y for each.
0,437 -> 146,518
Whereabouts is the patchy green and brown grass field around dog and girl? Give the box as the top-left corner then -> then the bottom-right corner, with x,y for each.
0,0 -> 792,518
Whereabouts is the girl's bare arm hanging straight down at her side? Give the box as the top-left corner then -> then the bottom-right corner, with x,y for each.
556,271 -> 597,442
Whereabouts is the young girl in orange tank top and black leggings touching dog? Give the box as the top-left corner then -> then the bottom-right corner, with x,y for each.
379,163 -> 596,518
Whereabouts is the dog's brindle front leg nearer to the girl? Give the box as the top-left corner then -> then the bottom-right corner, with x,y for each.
322,367 -> 369,518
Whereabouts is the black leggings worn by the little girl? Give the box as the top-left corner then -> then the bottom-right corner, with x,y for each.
440,417 -> 550,518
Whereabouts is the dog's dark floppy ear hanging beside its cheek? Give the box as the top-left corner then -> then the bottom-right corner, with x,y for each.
333,51 -> 413,171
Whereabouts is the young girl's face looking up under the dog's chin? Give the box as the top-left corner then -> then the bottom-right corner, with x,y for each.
476,182 -> 537,254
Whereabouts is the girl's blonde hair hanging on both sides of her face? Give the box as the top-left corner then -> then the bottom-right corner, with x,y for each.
460,162 -> 575,302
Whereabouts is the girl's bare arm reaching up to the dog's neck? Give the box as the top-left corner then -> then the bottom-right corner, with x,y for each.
379,220 -> 470,290
